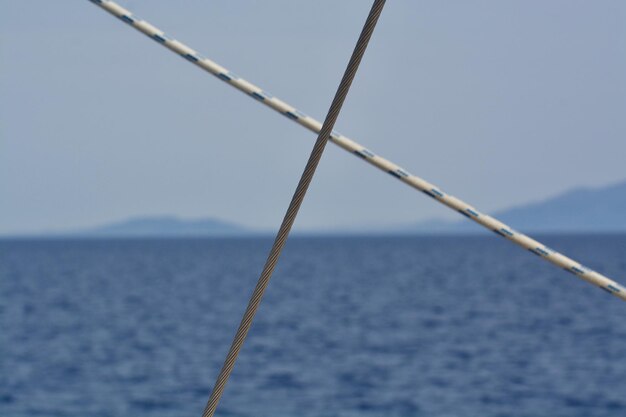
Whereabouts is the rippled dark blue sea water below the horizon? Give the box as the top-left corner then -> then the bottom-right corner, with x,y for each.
0,235 -> 626,417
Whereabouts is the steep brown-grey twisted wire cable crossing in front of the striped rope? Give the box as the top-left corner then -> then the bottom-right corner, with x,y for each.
202,0 -> 386,417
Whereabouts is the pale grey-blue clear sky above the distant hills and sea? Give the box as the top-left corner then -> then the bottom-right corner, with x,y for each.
0,0 -> 626,234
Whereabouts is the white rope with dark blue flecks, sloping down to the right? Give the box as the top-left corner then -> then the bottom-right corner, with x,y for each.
89,0 -> 626,301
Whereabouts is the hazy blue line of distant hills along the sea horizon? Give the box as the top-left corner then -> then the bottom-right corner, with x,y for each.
7,181 -> 626,238
